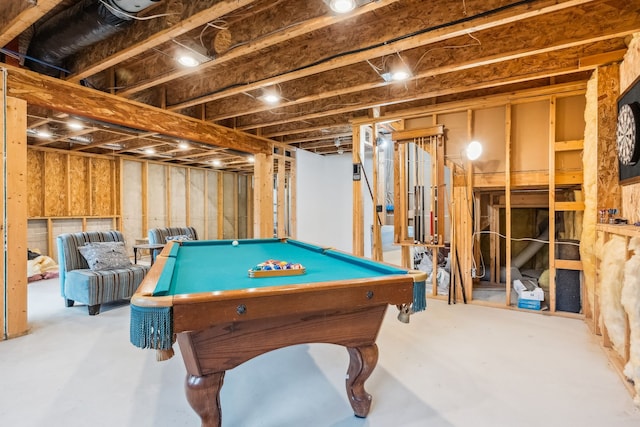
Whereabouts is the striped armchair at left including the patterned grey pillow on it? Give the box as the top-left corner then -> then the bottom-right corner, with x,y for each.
57,231 -> 149,316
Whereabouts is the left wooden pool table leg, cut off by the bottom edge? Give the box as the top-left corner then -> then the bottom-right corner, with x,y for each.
185,371 -> 224,427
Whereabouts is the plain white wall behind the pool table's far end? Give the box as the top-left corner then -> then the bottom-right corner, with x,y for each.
296,150 -> 353,252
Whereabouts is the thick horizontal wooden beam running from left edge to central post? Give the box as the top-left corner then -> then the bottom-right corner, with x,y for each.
5,66 -> 272,154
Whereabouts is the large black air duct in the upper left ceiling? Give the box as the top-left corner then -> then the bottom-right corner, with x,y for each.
25,0 -> 160,77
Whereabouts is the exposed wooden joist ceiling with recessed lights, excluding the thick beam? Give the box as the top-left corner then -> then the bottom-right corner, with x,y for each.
0,0 -> 640,171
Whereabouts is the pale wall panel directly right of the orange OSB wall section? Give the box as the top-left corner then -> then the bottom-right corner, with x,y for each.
121,160 -> 143,243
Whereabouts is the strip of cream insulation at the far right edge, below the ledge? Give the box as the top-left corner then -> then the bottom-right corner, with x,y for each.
621,237 -> 640,406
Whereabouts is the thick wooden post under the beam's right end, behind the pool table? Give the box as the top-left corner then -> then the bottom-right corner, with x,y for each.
253,148 -> 273,238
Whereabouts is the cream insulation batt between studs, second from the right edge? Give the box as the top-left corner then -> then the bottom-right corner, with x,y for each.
600,236 -> 627,356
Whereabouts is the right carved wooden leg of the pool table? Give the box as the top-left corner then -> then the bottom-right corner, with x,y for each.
346,343 -> 378,418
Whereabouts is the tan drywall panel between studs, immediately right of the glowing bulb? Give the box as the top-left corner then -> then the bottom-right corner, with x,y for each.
510,100 -> 549,172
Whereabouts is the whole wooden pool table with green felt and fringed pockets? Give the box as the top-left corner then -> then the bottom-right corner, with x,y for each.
131,238 -> 426,427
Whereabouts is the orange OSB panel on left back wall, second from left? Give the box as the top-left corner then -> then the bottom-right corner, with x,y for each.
43,152 -> 69,216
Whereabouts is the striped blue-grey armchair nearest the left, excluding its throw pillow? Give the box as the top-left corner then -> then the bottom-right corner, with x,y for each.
57,231 -> 149,316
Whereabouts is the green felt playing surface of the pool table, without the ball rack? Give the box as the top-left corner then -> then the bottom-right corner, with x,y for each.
154,238 -> 407,296
